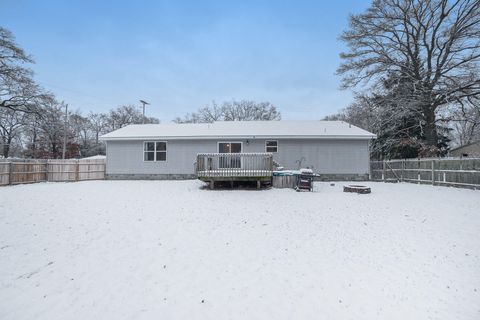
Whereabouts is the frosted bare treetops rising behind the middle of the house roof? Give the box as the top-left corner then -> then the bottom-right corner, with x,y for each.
173,100 -> 281,123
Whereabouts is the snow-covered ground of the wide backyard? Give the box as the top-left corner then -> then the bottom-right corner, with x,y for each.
0,181 -> 480,320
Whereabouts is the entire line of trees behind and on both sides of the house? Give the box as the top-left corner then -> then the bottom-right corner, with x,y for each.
0,0 -> 480,159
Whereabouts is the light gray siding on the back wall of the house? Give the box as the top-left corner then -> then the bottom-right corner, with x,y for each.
107,139 -> 369,174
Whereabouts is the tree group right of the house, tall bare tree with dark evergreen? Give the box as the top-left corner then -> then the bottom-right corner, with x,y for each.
326,0 -> 480,158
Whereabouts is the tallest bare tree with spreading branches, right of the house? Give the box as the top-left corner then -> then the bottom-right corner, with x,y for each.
338,0 -> 480,147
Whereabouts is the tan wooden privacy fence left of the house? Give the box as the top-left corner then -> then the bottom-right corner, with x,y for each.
0,159 -> 105,186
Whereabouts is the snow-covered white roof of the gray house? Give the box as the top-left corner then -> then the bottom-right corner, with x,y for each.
100,120 -> 376,141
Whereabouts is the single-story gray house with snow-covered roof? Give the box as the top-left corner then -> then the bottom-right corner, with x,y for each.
101,121 -> 375,179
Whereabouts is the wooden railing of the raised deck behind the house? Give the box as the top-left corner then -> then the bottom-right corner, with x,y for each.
195,153 -> 273,179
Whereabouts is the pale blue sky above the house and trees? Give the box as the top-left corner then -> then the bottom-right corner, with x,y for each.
0,0 -> 369,121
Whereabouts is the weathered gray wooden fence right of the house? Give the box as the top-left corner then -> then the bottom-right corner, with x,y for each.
370,158 -> 480,189
